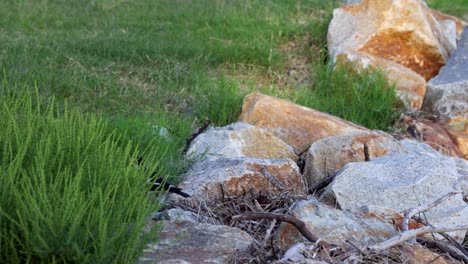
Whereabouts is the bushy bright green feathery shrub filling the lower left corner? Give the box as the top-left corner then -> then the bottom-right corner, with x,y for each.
0,82 -> 164,263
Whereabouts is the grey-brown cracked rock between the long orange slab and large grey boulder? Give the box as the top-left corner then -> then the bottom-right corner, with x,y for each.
304,131 -> 405,186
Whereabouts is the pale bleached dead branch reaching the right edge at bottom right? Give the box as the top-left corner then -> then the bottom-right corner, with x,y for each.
367,225 -> 468,251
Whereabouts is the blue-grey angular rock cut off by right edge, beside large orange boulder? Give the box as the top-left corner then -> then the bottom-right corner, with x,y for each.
424,28 -> 468,119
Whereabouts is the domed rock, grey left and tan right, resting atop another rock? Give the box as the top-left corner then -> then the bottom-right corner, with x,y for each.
187,122 -> 298,162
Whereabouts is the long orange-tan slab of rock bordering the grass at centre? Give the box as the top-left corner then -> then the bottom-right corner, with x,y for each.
239,93 -> 367,153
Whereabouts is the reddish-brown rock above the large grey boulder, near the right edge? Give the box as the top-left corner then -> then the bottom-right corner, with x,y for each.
405,117 -> 463,158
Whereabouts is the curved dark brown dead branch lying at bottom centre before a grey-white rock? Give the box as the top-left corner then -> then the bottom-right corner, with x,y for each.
232,213 -> 331,248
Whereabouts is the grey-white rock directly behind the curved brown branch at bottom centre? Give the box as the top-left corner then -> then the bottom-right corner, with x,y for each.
278,198 -> 397,248
